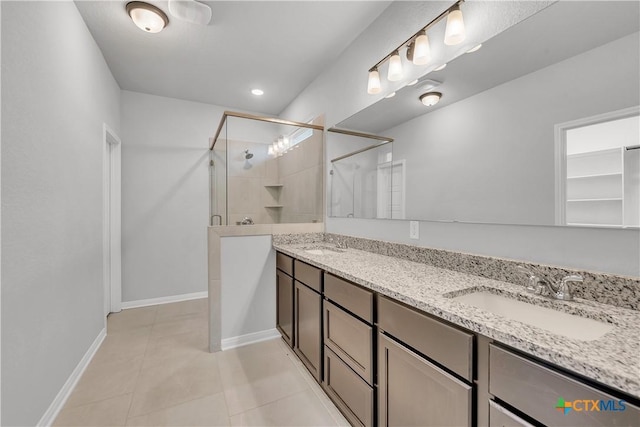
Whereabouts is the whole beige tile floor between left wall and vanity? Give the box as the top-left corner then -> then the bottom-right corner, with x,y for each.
54,299 -> 349,426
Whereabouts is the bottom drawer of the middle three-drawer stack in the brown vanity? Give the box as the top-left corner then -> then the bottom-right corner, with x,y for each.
322,346 -> 373,427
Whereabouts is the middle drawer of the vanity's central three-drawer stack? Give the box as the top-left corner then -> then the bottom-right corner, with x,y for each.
324,300 -> 373,385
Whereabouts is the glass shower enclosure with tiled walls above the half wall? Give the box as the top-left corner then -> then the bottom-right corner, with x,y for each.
209,111 -> 324,225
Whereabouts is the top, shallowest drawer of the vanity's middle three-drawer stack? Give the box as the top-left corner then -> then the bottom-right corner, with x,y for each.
324,273 -> 373,323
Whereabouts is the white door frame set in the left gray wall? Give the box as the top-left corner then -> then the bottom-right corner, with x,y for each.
102,123 -> 122,318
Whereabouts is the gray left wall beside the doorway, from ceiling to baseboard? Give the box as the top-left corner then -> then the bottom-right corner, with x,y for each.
1,1 -> 120,425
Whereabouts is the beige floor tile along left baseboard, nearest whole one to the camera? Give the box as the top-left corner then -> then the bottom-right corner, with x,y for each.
65,356 -> 143,408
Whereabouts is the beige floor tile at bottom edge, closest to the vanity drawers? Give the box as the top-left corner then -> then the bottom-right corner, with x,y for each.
231,390 -> 337,426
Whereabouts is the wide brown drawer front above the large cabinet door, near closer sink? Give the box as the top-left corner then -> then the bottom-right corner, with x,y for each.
378,296 -> 473,382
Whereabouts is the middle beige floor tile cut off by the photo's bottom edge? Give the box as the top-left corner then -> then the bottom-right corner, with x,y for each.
127,393 -> 229,426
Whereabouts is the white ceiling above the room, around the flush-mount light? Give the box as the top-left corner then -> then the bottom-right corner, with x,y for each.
76,0 -> 390,115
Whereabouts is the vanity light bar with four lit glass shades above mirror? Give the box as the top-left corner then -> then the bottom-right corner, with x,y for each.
367,0 -> 466,95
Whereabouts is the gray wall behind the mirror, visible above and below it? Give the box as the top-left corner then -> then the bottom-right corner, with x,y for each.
281,2 -> 640,276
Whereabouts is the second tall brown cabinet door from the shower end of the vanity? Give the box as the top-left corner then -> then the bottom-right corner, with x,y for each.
294,281 -> 322,382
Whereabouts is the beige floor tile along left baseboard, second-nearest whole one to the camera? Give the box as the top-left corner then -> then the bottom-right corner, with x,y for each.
91,326 -> 152,364
